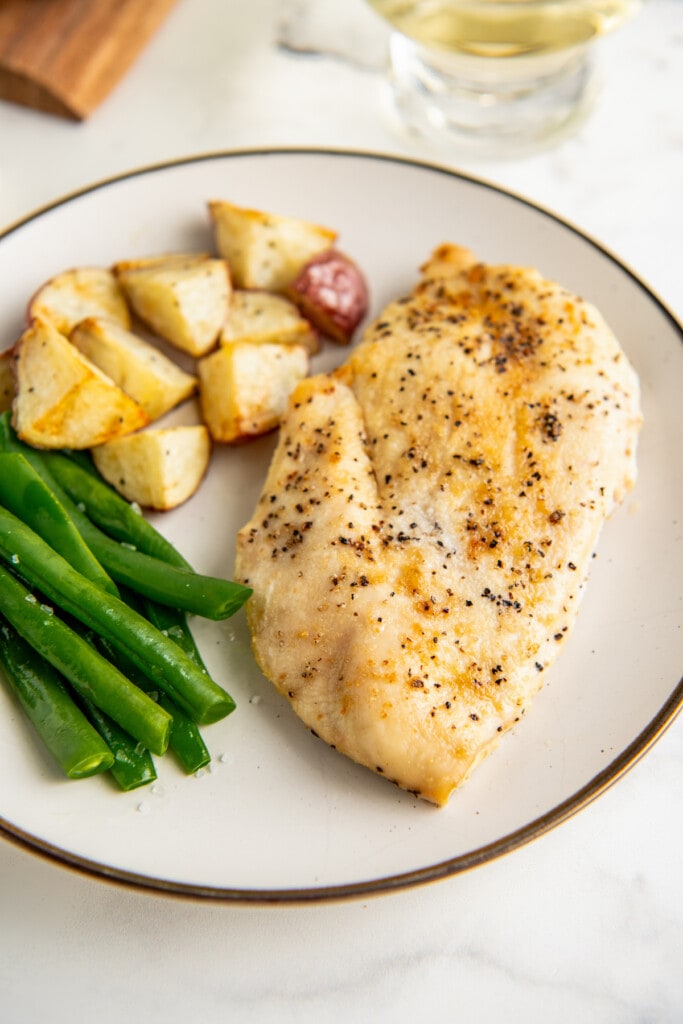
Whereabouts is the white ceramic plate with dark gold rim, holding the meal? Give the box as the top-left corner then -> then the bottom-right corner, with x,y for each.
0,151 -> 683,901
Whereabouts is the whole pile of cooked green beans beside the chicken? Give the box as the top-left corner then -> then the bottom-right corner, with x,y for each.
0,413 -> 251,790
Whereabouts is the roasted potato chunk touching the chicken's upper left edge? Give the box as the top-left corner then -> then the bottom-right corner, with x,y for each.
198,342 -> 308,442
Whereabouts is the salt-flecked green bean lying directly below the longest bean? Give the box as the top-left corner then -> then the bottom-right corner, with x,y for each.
0,565 -> 171,754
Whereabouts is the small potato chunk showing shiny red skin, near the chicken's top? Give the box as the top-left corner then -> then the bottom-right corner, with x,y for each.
287,249 -> 369,345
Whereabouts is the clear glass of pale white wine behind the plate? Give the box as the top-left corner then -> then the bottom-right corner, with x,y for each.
369,0 -> 641,147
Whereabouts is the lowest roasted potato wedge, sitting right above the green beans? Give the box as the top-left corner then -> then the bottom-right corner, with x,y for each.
92,424 -> 211,512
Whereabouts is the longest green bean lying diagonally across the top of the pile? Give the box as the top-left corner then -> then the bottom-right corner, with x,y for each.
0,508 -> 234,724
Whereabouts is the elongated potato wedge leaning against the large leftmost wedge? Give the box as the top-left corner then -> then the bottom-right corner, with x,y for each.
70,317 -> 198,420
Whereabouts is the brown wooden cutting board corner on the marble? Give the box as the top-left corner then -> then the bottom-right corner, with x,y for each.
0,0 -> 176,121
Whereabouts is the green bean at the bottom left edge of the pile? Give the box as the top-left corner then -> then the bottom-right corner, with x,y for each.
0,618 -> 114,778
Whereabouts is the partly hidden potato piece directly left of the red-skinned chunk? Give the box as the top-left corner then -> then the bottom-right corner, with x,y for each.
220,290 -> 321,355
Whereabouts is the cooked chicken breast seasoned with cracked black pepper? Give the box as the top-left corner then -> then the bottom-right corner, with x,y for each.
237,245 -> 641,805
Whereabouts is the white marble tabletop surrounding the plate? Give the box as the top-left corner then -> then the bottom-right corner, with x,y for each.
0,0 -> 683,1024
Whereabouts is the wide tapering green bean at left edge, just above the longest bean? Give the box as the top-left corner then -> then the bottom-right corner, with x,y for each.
0,452 -> 117,594
